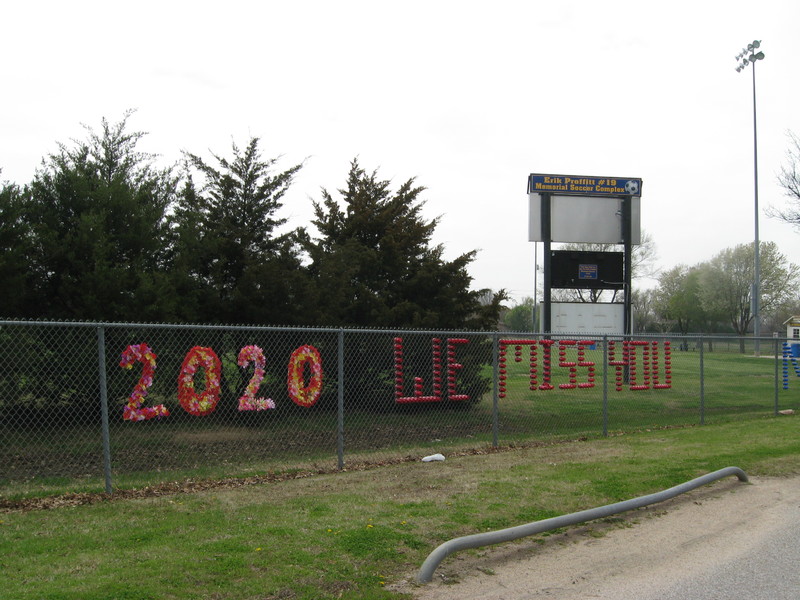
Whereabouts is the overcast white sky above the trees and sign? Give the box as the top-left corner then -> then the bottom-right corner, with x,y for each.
0,0 -> 800,300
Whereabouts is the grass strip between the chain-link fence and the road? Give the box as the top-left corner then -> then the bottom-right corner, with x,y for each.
0,417 -> 800,600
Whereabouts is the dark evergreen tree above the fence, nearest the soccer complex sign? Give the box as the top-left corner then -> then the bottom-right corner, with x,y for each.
306,160 -> 505,329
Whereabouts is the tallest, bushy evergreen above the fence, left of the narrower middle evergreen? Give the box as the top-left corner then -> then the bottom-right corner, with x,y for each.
26,112 -> 175,320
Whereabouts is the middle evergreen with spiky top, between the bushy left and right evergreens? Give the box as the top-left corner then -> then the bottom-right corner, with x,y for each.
180,138 -> 308,324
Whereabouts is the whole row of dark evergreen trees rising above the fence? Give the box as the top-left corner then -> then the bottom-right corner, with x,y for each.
0,112 -> 505,329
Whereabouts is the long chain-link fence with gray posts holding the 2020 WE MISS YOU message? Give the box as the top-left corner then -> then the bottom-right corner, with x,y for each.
0,321 -> 800,497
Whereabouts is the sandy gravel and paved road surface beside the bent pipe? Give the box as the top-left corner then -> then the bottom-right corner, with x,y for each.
404,478 -> 800,600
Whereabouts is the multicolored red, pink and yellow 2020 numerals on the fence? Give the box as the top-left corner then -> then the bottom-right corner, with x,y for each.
119,344 -> 322,421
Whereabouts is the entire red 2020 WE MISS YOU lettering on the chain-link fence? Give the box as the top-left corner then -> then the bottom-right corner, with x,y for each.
119,337 -> 672,421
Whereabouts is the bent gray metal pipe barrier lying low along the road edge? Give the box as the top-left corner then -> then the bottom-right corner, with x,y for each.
417,467 -> 748,583
